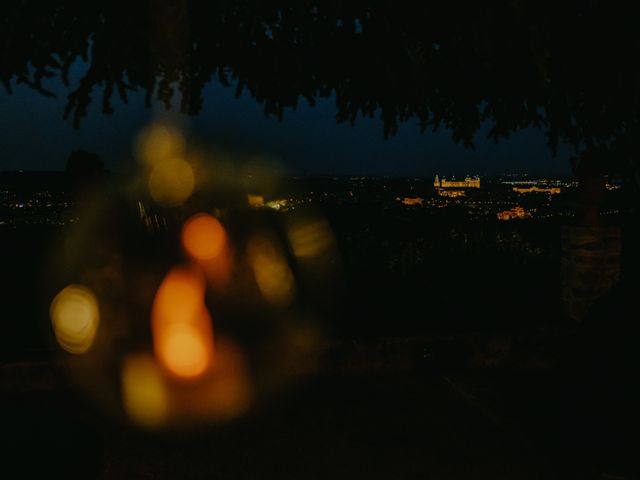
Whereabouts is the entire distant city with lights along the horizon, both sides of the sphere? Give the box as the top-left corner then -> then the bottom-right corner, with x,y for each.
0,172 -> 622,226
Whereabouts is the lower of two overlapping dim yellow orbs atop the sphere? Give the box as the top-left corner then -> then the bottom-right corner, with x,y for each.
149,157 -> 195,207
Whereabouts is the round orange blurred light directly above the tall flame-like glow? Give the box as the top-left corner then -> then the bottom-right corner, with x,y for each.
182,213 -> 227,261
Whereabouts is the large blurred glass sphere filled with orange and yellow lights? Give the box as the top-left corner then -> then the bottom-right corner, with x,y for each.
49,125 -> 339,429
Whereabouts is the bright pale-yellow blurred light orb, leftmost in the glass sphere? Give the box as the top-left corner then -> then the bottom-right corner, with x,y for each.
49,285 -> 100,355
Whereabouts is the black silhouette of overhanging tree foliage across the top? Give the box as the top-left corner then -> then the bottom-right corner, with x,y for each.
0,0 -> 640,169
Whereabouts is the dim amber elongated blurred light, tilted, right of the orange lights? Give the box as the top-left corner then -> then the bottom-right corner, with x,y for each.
247,235 -> 296,306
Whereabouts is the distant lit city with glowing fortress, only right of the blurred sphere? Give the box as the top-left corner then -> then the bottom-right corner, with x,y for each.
242,175 -> 621,221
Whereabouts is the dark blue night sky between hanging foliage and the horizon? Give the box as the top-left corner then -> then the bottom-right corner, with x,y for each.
0,74 -> 571,176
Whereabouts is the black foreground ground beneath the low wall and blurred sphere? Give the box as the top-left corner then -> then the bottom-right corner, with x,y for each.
0,346 -> 636,479
